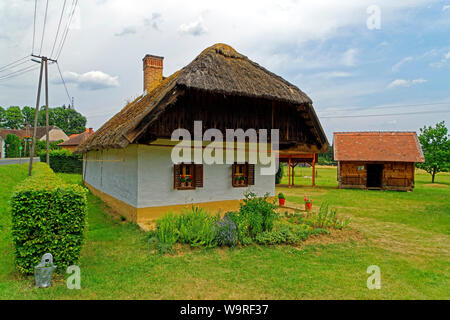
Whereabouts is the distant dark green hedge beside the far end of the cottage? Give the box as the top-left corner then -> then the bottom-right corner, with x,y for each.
39,149 -> 83,174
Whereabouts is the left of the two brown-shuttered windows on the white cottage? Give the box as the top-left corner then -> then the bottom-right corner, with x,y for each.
173,163 -> 203,190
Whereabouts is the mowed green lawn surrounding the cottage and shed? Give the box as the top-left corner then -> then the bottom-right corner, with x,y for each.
0,165 -> 450,299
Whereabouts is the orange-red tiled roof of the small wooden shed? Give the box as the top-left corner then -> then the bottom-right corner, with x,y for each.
333,131 -> 425,162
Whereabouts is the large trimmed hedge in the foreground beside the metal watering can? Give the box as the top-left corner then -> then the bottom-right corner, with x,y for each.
11,163 -> 87,273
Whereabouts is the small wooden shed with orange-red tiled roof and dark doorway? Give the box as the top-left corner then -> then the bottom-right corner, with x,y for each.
333,131 -> 425,191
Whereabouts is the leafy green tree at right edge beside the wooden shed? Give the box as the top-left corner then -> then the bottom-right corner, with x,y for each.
417,121 -> 450,183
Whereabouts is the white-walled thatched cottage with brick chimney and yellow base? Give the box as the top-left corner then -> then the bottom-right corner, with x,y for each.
76,44 -> 329,222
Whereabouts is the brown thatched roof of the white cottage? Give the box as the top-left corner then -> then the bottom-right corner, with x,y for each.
76,44 -> 326,152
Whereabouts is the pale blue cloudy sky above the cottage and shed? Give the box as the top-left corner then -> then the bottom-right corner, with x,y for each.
0,0 -> 450,142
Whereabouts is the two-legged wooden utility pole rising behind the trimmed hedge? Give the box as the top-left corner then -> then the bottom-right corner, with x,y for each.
28,54 -> 56,176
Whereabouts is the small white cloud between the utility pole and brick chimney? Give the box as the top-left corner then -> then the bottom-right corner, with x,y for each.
60,71 -> 119,90
